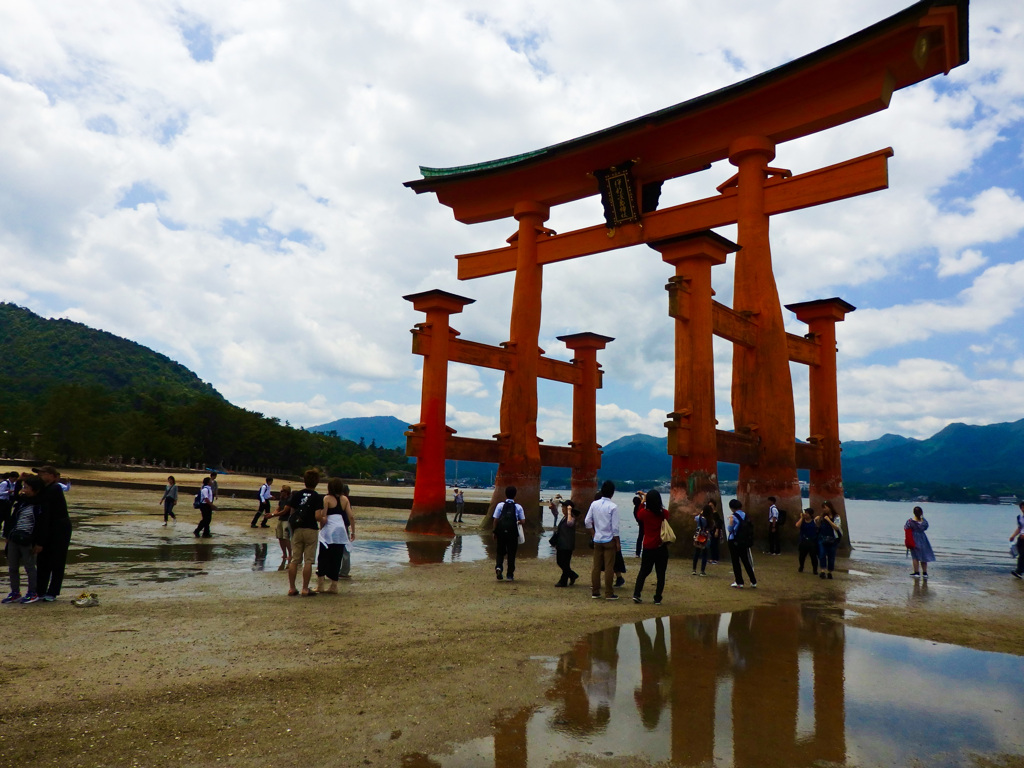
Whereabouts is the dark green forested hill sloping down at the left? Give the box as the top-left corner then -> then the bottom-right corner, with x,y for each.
0,304 -> 410,477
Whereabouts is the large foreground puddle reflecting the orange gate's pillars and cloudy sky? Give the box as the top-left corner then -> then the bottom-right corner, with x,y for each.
402,605 -> 1024,768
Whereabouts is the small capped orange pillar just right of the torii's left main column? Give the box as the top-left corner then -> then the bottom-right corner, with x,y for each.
558,333 -> 614,512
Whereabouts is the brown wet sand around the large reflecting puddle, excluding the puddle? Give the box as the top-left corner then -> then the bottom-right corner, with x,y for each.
0,480 -> 1024,766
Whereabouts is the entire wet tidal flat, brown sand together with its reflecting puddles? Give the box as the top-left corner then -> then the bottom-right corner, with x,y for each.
0,475 -> 1024,768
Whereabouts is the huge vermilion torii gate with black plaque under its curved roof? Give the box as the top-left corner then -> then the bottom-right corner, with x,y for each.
407,0 -> 968,541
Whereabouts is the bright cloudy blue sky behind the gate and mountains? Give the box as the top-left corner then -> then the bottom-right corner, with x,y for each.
0,0 -> 1024,444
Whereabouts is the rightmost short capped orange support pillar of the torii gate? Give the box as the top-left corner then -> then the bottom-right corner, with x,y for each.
785,298 -> 855,552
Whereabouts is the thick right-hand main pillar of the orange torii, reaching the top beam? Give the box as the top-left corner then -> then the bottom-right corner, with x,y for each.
729,136 -> 801,520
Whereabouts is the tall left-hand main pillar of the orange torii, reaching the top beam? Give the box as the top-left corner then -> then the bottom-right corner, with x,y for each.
489,202 -> 550,528
